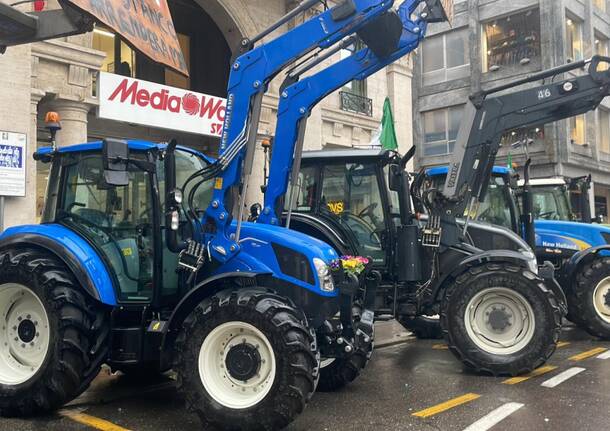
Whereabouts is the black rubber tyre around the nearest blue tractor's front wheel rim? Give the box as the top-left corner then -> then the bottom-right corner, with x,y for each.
174,289 -> 320,430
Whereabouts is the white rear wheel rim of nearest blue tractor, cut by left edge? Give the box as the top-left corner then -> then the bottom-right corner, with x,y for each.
0,283 -> 50,386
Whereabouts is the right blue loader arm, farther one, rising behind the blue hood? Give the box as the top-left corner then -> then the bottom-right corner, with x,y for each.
258,0 -> 448,225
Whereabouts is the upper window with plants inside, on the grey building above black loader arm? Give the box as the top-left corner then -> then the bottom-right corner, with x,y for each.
482,9 -> 540,72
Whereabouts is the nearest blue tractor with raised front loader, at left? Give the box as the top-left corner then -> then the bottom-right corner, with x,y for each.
0,0 -> 432,429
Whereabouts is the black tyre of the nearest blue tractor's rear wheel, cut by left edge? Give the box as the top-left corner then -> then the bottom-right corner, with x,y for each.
0,248 -> 109,417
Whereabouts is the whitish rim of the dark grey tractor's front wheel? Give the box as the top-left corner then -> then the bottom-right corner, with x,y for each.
464,287 -> 536,355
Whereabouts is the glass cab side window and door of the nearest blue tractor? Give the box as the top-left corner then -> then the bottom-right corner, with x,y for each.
57,154 -> 154,301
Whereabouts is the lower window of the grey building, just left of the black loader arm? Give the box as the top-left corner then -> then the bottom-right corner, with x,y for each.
423,106 -> 464,156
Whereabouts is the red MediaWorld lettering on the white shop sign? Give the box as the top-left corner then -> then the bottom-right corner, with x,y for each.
108,79 -> 226,127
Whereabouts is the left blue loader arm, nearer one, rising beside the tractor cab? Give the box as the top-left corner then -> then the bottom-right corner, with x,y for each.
202,0 -> 393,262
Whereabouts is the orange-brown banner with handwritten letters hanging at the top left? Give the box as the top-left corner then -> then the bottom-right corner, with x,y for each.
66,0 -> 188,76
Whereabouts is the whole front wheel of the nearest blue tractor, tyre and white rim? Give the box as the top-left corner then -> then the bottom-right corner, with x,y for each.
174,289 -> 319,430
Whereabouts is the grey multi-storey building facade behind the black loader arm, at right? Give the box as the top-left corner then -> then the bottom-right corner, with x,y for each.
413,0 -> 610,217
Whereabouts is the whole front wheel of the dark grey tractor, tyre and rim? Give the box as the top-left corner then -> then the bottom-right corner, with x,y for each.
441,263 -> 563,376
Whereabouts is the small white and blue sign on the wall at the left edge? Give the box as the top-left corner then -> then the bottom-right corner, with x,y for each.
0,131 -> 27,197
